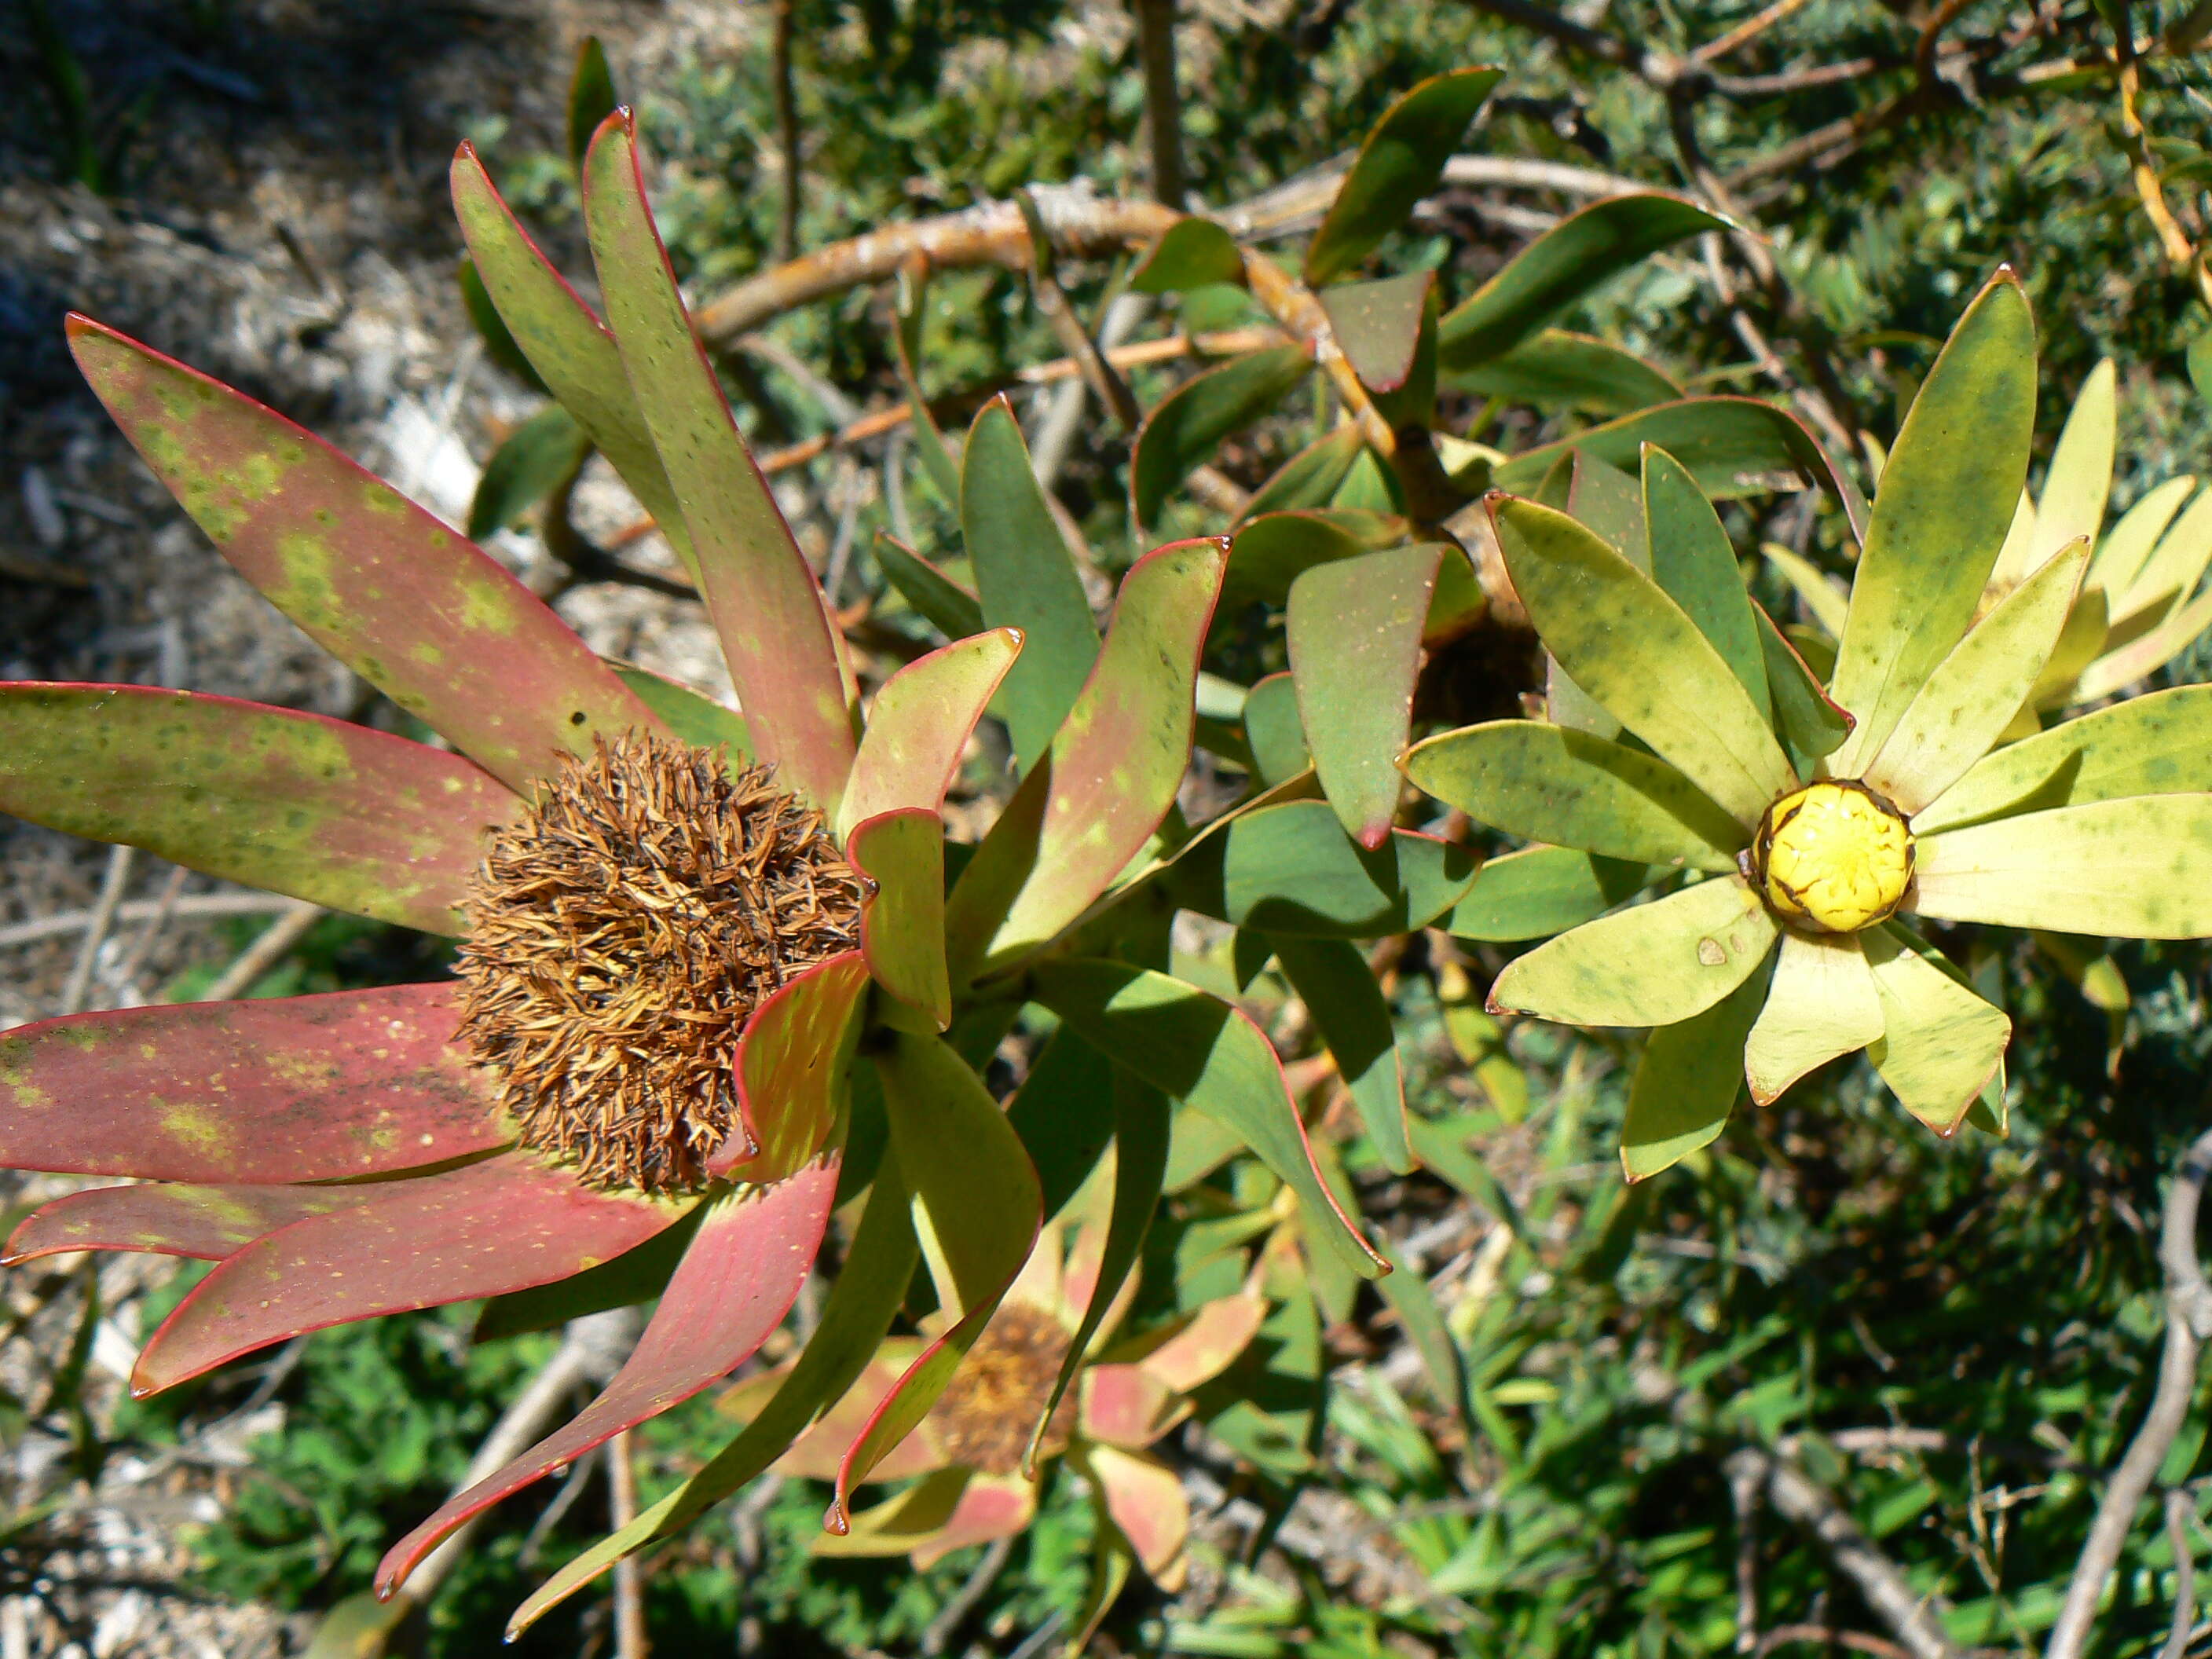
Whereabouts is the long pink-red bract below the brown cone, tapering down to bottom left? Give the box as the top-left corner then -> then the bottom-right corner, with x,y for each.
376,1155 -> 838,1595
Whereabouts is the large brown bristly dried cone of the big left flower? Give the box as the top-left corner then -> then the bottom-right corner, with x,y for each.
456,732 -> 860,1192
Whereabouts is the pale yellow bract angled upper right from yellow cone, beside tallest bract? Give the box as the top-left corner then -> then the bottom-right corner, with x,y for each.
1860,542 -> 2088,816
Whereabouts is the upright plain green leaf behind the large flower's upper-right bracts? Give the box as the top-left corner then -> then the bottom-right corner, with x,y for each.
960,398 -> 1100,775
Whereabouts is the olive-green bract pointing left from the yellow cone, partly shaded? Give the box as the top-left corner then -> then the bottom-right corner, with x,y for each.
1404,721 -> 1749,873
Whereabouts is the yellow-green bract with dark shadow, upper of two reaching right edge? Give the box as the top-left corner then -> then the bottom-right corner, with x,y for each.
1914,686 -> 2212,836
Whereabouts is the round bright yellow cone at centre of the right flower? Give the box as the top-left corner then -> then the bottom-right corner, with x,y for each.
1752,781 -> 1914,933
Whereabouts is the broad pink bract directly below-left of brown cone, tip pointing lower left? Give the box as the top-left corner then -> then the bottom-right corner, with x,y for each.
130,1152 -> 681,1396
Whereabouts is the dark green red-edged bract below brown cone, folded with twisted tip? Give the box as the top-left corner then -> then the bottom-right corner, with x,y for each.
827,1031 -> 1044,1533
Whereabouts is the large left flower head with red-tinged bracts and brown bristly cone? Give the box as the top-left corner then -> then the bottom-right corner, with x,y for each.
0,111 -> 1380,1636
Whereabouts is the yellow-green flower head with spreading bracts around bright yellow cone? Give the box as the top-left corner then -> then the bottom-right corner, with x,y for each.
1404,272 -> 2212,1179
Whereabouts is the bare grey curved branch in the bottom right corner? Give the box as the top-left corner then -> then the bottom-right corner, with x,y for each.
2044,1130 -> 2212,1659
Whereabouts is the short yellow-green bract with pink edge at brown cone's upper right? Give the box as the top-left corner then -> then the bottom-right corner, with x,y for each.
836,628 -> 1022,834
